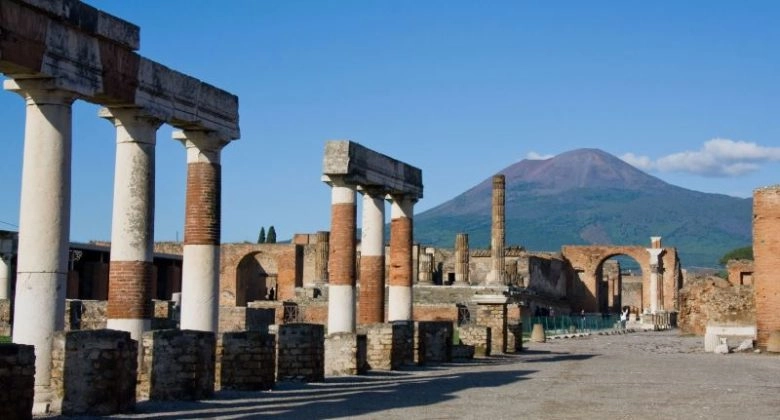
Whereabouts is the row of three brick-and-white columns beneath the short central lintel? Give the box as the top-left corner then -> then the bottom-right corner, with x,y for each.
328,182 -> 415,333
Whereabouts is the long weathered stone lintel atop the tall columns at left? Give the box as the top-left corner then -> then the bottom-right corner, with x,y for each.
0,0 -> 240,140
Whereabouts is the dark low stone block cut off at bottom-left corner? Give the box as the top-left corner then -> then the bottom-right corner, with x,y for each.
0,343 -> 35,419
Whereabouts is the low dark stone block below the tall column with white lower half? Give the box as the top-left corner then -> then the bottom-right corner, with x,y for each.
138,330 -> 216,400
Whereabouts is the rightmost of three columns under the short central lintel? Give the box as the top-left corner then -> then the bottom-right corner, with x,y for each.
387,196 -> 414,321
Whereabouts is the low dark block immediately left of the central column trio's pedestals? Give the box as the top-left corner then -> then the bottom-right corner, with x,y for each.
276,324 -> 325,382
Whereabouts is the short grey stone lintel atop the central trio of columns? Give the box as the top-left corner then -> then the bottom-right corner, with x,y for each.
322,140 -> 423,200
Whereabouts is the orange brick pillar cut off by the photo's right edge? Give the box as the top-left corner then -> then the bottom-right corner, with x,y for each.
753,185 -> 780,348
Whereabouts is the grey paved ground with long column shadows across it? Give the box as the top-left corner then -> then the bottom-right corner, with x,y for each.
47,331 -> 780,420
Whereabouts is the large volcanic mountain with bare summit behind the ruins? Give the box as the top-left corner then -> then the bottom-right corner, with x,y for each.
414,149 -> 752,267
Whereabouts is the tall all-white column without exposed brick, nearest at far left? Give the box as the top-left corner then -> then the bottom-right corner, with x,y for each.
4,79 -> 74,402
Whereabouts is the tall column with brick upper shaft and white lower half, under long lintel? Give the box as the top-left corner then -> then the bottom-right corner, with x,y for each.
173,130 -> 225,332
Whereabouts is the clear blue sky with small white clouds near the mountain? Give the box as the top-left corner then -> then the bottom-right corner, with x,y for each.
0,0 -> 780,242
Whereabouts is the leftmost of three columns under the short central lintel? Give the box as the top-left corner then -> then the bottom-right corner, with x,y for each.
328,183 -> 357,334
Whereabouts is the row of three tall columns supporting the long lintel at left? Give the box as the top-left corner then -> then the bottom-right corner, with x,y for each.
4,79 -> 227,400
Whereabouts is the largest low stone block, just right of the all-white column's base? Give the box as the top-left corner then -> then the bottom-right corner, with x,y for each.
51,329 -> 138,416
